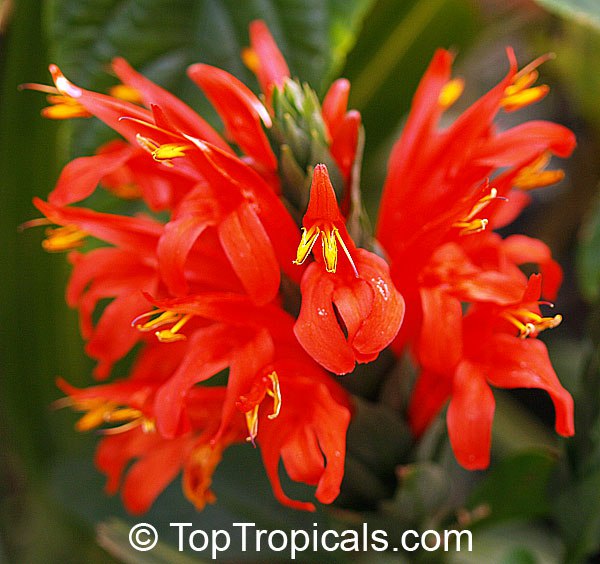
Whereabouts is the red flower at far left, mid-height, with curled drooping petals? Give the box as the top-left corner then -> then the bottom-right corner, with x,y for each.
34,199 -> 162,378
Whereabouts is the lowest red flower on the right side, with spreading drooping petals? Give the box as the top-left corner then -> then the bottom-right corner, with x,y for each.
409,275 -> 574,470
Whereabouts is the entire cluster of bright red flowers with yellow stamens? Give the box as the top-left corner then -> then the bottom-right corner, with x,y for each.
30,22 -> 574,512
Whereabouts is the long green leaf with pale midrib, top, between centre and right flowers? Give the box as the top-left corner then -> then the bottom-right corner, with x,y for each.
342,0 -> 478,214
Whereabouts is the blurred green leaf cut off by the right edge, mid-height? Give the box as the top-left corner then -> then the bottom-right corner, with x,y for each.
577,192 -> 600,302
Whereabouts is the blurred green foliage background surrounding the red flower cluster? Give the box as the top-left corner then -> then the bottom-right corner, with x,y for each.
0,0 -> 600,564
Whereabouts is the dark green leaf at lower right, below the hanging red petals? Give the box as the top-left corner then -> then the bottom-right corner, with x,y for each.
468,452 -> 556,522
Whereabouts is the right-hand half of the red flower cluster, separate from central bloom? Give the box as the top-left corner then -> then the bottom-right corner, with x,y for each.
377,50 -> 575,469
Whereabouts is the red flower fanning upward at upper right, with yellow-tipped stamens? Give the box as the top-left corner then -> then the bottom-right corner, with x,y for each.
377,50 -> 575,270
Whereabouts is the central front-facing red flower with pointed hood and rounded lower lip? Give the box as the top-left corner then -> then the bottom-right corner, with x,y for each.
294,165 -> 404,374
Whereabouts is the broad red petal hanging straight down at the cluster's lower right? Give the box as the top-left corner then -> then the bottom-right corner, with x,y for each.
446,361 -> 496,470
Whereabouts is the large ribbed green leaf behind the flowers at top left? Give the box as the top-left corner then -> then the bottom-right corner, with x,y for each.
50,0 -> 372,153
